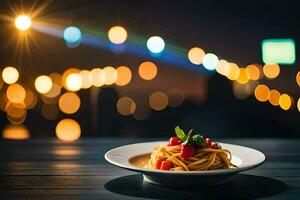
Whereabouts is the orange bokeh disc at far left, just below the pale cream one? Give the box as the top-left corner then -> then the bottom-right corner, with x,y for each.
6,84 -> 26,103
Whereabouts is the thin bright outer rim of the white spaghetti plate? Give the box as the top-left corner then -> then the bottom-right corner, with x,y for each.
104,140 -> 266,176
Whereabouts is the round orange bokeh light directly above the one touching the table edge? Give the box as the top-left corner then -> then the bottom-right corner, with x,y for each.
58,92 -> 81,114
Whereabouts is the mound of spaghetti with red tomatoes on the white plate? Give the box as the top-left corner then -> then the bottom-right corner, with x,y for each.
148,127 -> 236,171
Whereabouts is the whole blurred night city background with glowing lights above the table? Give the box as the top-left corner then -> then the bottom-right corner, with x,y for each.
0,0 -> 300,141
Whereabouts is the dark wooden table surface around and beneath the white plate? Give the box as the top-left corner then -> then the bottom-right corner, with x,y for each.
0,138 -> 300,199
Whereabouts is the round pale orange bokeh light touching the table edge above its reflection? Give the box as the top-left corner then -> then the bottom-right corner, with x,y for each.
55,118 -> 81,142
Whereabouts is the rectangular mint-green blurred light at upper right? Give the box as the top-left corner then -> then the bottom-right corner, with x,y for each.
262,39 -> 296,64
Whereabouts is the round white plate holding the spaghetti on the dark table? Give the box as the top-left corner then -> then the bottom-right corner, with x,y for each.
105,141 -> 265,187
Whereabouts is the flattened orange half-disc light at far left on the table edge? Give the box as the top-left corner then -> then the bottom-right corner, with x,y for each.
2,125 -> 30,140
